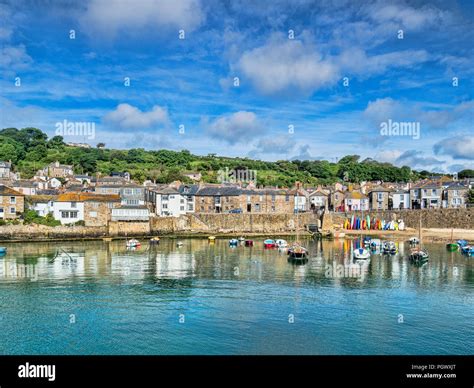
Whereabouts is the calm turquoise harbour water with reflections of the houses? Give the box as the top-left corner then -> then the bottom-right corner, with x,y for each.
0,239 -> 474,354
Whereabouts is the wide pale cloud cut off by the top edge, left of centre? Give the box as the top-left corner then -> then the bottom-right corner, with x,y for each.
80,0 -> 205,38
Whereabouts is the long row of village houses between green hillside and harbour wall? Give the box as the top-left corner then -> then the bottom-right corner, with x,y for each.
0,162 -> 474,226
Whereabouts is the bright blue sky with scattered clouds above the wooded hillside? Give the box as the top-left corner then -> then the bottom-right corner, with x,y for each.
0,0 -> 474,172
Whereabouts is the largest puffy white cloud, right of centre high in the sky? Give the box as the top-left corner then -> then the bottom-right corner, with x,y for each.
236,37 -> 339,95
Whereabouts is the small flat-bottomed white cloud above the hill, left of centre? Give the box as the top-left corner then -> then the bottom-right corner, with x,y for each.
104,104 -> 169,129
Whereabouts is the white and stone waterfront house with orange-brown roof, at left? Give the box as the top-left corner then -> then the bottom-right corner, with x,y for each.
53,193 -> 120,226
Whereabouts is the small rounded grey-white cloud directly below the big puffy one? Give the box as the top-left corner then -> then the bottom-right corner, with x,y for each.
203,111 -> 264,144
